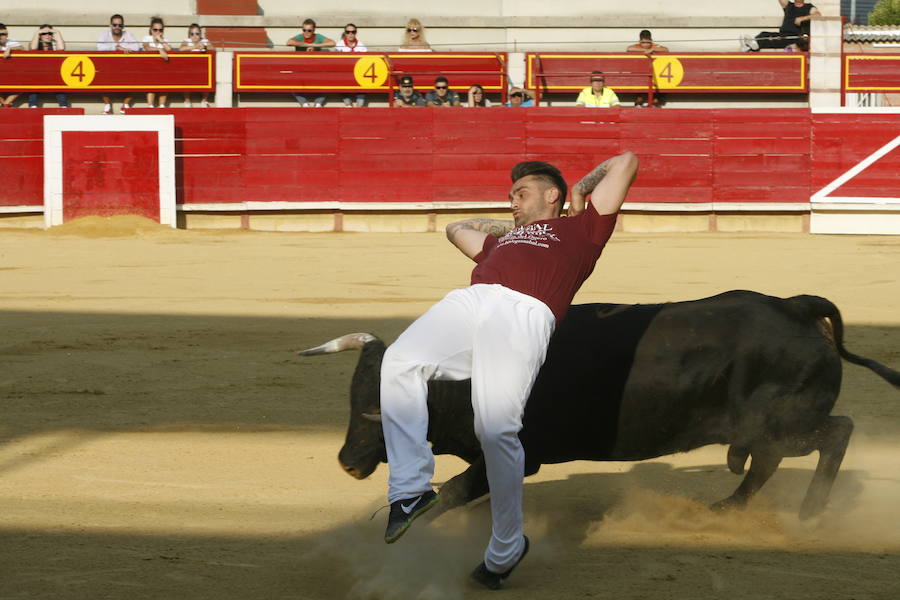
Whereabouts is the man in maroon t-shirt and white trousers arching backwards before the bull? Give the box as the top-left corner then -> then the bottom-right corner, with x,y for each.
381,152 -> 638,589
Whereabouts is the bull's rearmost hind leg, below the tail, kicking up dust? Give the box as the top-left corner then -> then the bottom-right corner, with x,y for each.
799,417 -> 853,519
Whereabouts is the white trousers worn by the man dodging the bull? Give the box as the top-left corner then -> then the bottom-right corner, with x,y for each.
381,284 -> 556,573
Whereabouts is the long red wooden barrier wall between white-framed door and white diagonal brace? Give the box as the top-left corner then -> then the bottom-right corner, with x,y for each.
125,108 -> 810,208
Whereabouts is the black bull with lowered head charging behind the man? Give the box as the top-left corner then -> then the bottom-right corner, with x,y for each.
301,291 -> 900,518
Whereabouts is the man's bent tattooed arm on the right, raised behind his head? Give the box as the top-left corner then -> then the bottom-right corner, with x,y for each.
568,152 -> 638,217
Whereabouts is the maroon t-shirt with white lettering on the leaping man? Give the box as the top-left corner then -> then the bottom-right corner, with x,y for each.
472,202 -> 616,323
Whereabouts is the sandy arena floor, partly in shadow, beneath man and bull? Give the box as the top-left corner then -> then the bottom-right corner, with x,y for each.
0,219 -> 900,600
